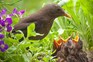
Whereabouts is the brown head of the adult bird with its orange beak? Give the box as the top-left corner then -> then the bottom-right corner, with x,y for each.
43,4 -> 71,18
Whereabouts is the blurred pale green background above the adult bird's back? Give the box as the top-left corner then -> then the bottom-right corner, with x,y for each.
0,0 -> 53,14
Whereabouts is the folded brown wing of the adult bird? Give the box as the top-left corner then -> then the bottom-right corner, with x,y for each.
14,17 -> 37,31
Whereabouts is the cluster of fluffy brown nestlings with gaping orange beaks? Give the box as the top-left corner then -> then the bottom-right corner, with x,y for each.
52,36 -> 88,62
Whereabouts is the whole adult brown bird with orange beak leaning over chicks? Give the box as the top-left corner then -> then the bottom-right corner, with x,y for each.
13,3 -> 71,40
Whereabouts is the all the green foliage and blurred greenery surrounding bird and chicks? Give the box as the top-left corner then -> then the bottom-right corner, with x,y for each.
0,0 -> 93,62
